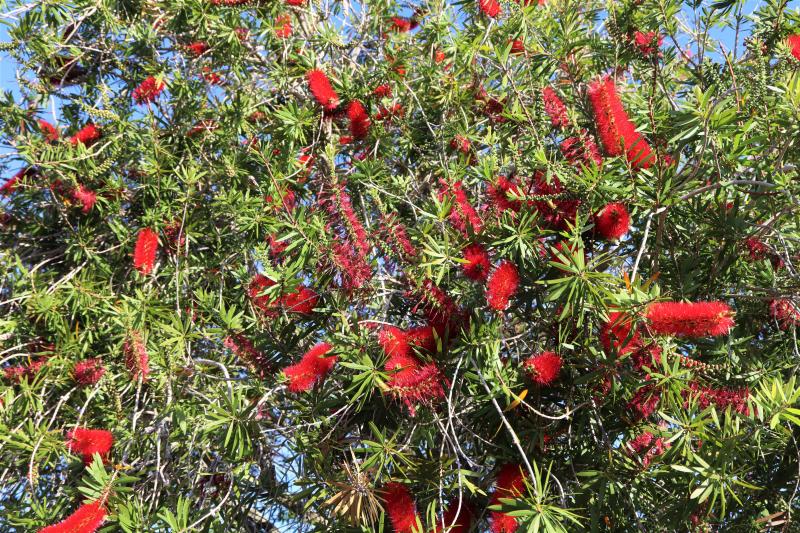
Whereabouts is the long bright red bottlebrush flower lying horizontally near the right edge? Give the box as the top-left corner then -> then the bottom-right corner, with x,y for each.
647,302 -> 734,337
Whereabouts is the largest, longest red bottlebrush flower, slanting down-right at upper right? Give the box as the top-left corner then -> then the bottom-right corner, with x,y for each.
588,77 -> 654,168
